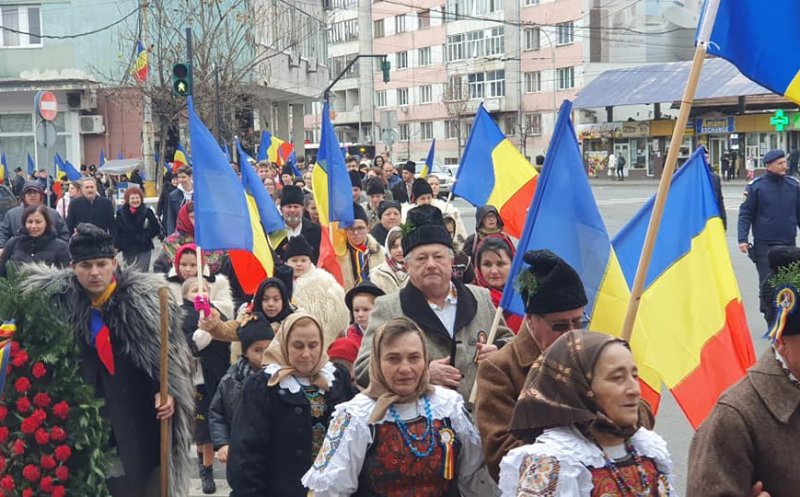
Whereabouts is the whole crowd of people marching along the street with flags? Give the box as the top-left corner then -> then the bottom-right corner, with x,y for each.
0,148 -> 800,497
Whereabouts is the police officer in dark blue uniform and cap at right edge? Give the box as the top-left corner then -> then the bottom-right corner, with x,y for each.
739,150 -> 800,286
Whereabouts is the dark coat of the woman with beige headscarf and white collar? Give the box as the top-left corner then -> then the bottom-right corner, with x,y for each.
228,366 -> 355,497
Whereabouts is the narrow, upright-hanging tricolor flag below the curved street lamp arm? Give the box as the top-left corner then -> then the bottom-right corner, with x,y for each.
311,102 -> 353,284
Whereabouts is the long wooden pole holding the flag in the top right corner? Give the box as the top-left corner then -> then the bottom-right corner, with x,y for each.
622,0 -> 719,342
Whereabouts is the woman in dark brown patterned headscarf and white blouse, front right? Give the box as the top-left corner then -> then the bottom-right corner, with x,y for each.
500,330 -> 675,497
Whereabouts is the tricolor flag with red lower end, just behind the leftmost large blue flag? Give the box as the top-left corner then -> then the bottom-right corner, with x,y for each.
228,140 -> 285,295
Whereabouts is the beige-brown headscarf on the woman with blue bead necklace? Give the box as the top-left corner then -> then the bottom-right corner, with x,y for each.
362,317 -> 433,424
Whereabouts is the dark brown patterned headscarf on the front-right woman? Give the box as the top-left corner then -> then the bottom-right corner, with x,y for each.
511,330 -> 638,440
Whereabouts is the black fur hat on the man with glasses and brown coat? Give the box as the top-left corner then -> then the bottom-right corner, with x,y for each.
517,249 -> 589,314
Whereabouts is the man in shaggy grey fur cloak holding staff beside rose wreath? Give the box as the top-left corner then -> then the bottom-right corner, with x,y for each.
23,223 -> 195,497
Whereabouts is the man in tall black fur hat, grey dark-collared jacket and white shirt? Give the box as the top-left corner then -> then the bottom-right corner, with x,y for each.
355,205 -> 514,401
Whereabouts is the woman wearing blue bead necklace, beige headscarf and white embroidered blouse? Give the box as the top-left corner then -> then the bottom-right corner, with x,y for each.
303,317 -> 498,497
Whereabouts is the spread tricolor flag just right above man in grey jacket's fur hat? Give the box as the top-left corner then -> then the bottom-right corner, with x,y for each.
453,105 -> 539,238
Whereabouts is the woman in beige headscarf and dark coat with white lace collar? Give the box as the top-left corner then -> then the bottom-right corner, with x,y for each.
228,312 -> 355,497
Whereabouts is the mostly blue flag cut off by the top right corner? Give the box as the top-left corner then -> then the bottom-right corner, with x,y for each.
697,0 -> 800,103
